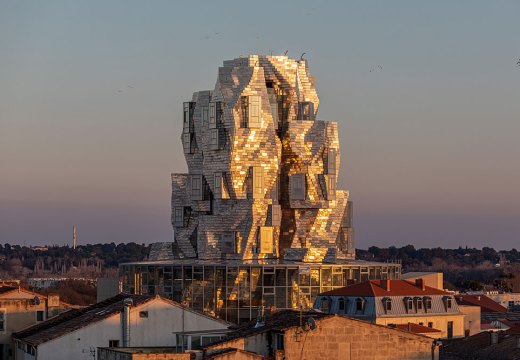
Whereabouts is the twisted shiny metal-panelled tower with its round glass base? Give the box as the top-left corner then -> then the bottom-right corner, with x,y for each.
120,55 -> 401,322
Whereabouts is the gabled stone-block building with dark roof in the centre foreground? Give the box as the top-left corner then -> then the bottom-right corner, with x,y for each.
205,310 -> 437,360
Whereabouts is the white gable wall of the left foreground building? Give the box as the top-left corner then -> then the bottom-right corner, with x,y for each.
17,299 -> 227,360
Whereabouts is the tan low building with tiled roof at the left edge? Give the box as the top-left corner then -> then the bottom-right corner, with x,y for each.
0,286 -> 70,359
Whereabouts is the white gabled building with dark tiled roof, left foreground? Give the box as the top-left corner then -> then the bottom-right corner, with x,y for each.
13,294 -> 230,360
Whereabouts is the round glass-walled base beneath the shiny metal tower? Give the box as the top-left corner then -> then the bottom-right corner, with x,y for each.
120,260 -> 401,323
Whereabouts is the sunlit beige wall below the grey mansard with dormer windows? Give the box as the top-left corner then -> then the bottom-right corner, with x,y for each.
376,314 -> 464,338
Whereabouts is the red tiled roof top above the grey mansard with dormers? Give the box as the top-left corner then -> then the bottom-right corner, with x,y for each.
320,280 -> 450,297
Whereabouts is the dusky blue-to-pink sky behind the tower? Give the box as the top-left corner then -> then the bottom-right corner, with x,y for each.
0,0 -> 520,249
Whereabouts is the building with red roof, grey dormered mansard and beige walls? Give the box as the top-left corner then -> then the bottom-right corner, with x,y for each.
314,279 -> 464,338
